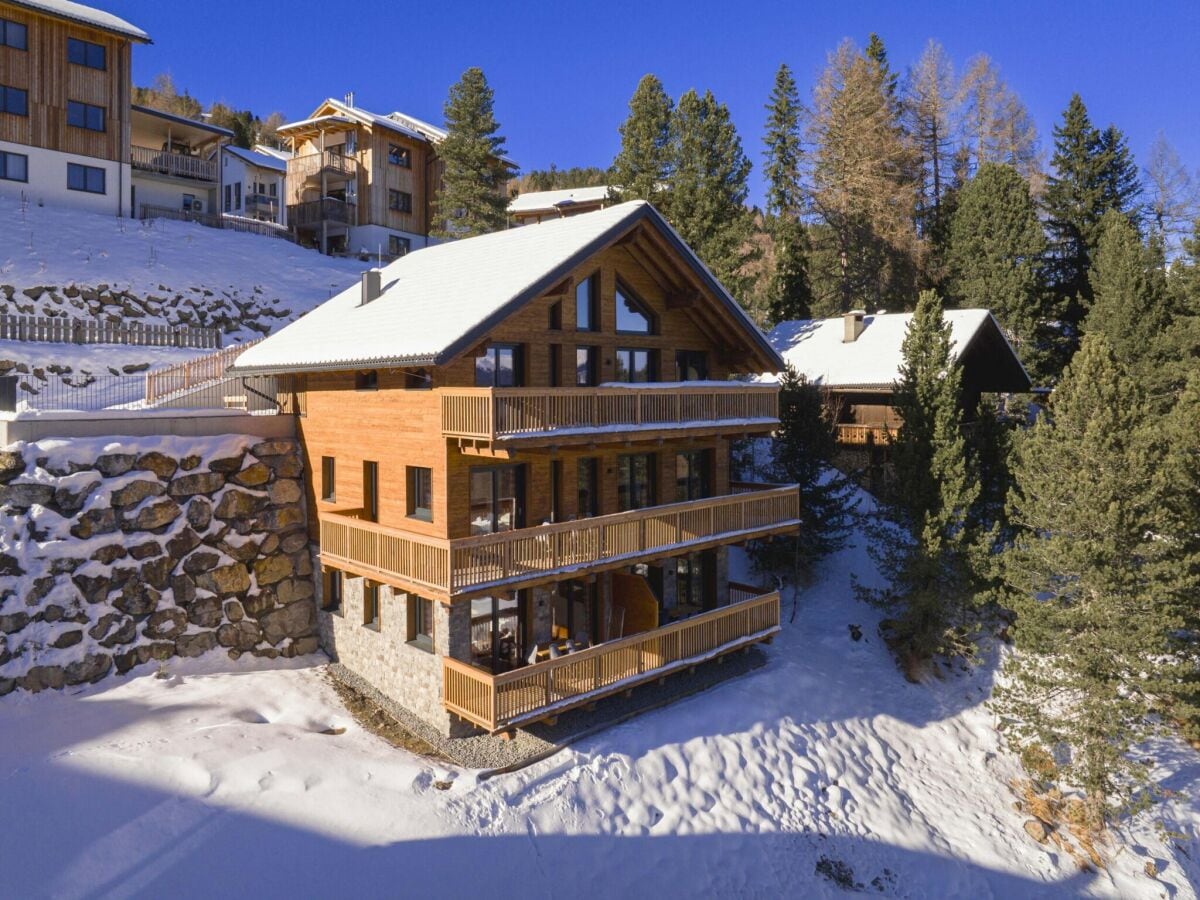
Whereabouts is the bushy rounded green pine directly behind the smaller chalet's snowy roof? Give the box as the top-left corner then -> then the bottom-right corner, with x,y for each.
947,162 -> 1048,368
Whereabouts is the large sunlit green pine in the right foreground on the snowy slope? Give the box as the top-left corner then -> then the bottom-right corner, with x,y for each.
996,335 -> 1182,822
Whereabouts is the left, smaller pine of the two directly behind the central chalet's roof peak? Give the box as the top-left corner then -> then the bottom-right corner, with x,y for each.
610,74 -> 673,206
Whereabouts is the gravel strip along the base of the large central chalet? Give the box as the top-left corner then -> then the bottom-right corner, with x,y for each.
329,646 -> 767,778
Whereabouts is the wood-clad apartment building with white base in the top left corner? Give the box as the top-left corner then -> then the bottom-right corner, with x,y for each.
0,0 -> 150,215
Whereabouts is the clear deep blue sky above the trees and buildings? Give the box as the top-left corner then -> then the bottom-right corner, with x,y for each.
108,0 -> 1200,202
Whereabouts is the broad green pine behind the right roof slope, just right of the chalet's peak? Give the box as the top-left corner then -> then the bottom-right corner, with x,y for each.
667,90 -> 754,299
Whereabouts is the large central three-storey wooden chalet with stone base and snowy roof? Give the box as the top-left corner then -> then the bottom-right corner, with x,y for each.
232,202 -> 798,734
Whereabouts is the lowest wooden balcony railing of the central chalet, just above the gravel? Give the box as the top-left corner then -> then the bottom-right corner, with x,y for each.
442,592 -> 779,732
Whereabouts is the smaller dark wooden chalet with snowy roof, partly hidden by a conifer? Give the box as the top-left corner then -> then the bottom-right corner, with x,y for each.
768,310 -> 1031,445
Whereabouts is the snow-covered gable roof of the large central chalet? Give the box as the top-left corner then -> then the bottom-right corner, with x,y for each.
234,200 -> 782,373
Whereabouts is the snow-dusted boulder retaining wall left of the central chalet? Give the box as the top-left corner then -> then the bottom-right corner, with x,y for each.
0,434 -> 318,695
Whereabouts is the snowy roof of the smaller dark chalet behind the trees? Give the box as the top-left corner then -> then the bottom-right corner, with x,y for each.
767,310 -> 1030,392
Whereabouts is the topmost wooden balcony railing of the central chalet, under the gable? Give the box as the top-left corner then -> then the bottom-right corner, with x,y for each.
438,382 -> 779,440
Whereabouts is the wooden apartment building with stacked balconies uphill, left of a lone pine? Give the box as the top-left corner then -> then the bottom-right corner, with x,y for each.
276,96 -> 508,258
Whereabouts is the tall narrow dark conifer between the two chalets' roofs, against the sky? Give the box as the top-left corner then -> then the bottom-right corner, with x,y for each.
763,64 -> 812,323
